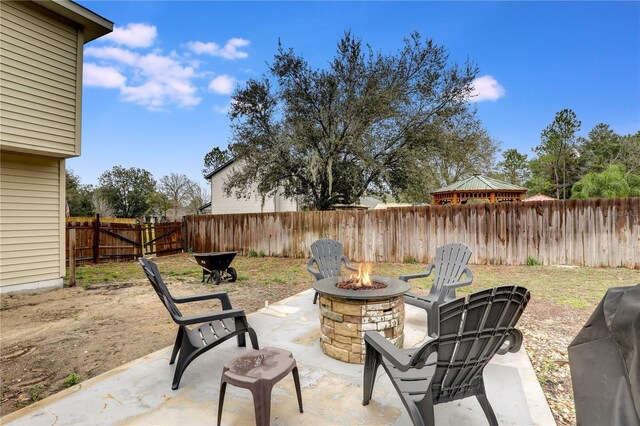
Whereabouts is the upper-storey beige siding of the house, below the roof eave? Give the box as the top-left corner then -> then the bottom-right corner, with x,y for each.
0,1 -> 83,158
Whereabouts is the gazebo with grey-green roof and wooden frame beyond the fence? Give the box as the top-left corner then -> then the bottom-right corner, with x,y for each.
431,174 -> 528,204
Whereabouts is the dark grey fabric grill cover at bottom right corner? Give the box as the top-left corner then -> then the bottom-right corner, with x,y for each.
569,285 -> 640,426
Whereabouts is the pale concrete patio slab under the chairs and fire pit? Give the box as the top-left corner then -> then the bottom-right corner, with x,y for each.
0,290 -> 555,426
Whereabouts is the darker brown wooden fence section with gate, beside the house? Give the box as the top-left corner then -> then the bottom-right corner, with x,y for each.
66,215 -> 182,265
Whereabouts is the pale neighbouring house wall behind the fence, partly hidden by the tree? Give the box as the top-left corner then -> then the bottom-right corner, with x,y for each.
209,162 -> 299,214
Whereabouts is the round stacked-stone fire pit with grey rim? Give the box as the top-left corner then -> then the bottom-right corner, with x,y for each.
313,276 -> 409,364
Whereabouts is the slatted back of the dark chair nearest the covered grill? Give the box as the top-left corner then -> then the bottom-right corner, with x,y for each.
431,286 -> 531,403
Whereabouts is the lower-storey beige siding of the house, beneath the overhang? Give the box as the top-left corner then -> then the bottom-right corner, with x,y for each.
0,152 -> 65,292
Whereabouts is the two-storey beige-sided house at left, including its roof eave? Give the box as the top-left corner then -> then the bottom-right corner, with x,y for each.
0,0 -> 113,294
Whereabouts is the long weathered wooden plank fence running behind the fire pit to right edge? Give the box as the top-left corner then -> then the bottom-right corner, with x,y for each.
184,198 -> 640,269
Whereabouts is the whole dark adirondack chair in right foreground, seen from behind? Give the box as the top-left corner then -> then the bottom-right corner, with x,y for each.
362,286 -> 530,425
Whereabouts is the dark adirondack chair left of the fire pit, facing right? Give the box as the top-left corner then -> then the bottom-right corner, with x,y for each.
138,257 -> 259,389
